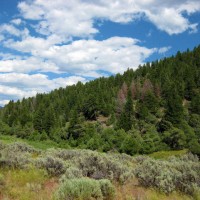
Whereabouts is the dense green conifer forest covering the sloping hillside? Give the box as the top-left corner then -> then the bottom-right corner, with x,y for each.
0,46 -> 200,155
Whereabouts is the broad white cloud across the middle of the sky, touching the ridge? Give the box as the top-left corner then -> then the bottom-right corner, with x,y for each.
3,37 -> 157,74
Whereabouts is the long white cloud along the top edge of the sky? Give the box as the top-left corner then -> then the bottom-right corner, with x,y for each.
18,0 -> 200,37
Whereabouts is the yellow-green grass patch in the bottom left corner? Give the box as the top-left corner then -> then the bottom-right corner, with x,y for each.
0,168 -> 53,200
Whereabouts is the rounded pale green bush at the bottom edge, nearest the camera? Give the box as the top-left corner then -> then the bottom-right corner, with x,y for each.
55,178 -> 115,200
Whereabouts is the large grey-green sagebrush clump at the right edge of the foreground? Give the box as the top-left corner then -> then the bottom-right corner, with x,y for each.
135,154 -> 200,195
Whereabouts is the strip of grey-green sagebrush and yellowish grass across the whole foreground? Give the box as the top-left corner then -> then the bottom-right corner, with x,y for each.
0,139 -> 200,200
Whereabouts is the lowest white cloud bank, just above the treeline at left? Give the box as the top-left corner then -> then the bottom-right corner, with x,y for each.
0,73 -> 86,105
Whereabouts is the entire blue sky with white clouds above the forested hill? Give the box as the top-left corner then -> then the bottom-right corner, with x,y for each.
0,0 -> 200,106
